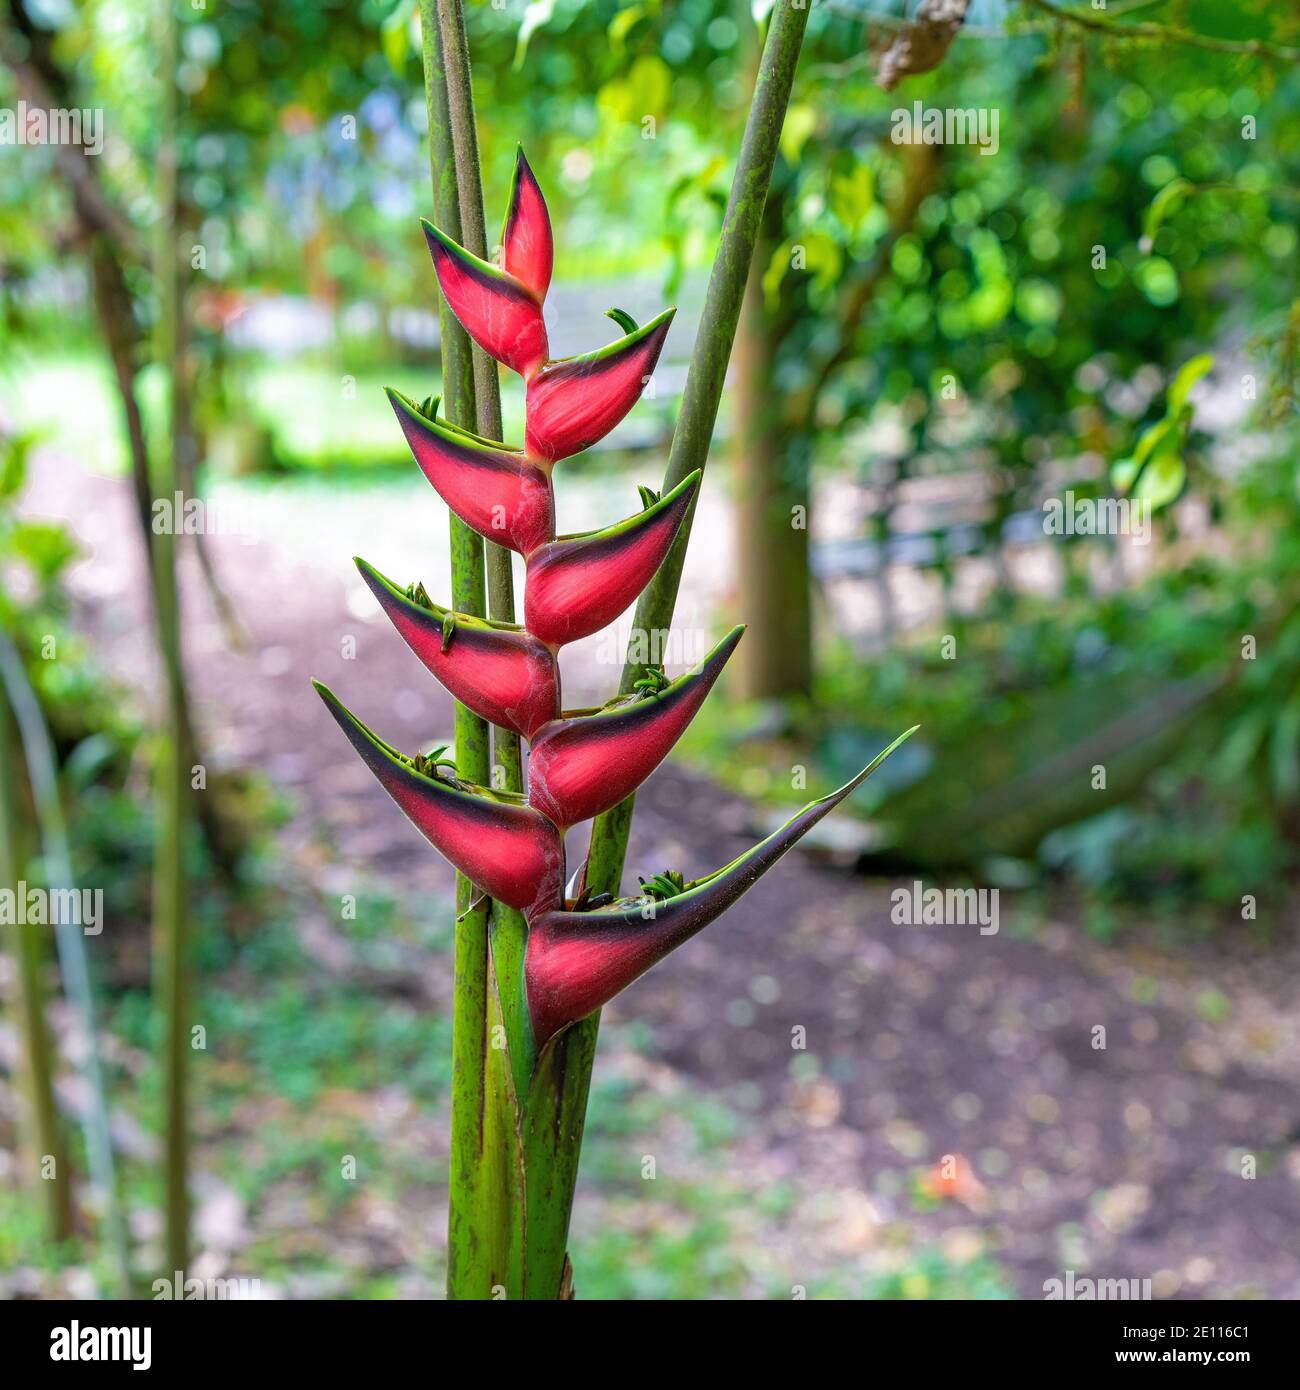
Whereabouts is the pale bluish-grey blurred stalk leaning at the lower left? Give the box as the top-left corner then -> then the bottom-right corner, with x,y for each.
0,630 -> 131,1298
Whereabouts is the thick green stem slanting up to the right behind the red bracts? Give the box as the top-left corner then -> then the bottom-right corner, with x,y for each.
526,0 -> 811,1298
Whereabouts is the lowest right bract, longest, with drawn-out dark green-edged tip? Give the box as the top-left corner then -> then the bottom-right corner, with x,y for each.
524,730 -> 915,1047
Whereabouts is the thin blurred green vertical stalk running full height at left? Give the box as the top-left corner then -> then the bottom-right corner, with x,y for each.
150,0 -> 190,1275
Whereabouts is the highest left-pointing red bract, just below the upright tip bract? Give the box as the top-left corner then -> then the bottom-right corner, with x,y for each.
421,221 -> 549,379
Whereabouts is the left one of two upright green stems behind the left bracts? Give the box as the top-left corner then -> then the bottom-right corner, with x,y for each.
420,0 -> 506,1298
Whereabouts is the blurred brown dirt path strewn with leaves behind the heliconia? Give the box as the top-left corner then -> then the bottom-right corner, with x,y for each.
22,457 -> 1300,1297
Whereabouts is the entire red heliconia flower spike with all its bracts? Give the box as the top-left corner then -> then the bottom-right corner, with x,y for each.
317,152 -> 912,1045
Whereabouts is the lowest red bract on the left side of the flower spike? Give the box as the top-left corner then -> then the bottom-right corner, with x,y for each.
311,681 -> 564,915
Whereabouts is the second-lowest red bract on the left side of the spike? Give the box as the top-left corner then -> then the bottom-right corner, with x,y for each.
355,559 -> 560,738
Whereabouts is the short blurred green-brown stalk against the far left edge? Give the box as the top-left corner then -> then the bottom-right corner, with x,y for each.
0,682 -> 72,1244
